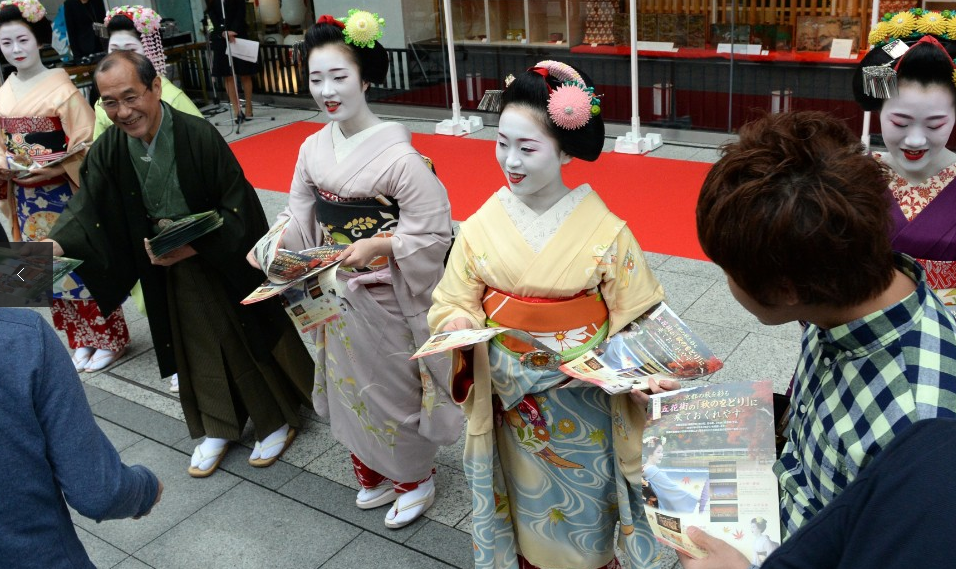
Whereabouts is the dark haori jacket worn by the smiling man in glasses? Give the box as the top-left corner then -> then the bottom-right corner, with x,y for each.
50,106 -> 289,376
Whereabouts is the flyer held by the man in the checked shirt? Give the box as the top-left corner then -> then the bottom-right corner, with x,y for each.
642,380 -> 780,565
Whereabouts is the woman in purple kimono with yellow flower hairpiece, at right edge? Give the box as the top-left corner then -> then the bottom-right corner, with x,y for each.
853,9 -> 956,311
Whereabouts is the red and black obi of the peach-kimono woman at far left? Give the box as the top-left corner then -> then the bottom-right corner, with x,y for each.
0,116 -> 70,187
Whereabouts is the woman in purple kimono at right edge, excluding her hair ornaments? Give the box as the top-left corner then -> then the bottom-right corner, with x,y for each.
854,31 -> 956,311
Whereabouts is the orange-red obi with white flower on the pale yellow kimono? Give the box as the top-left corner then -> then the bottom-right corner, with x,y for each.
482,287 -> 608,354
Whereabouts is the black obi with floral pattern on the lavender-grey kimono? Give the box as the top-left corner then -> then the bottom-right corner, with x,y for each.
315,190 -> 399,271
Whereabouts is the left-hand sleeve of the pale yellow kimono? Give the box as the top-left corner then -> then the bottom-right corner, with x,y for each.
428,222 -> 486,334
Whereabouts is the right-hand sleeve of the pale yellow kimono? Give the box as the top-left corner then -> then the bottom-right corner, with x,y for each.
600,225 -> 664,335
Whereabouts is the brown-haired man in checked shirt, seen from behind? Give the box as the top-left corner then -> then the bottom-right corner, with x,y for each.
697,112 -> 956,535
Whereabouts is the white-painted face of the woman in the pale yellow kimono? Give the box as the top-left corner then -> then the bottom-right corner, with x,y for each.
495,105 -> 569,210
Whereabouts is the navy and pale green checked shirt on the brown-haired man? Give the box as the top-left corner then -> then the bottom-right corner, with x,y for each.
774,254 -> 956,535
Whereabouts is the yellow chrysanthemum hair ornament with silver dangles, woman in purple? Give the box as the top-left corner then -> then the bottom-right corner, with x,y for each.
862,8 -> 956,99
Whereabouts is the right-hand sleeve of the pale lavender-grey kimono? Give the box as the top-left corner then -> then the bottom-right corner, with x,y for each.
386,152 -> 452,296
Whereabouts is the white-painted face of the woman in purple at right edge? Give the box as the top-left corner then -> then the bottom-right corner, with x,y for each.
880,81 -> 956,183
